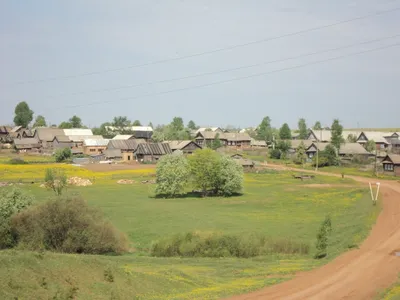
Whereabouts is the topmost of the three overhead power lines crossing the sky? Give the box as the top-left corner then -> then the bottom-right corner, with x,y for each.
2,7 -> 400,86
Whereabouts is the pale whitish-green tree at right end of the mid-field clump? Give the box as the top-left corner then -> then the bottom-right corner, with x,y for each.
216,155 -> 243,196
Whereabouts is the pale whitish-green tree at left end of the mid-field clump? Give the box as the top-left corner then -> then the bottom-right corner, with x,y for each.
156,151 -> 189,197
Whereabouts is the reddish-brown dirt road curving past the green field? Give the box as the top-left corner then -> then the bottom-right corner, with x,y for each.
230,166 -> 400,300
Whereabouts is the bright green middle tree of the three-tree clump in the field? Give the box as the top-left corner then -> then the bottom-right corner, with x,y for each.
188,148 -> 221,195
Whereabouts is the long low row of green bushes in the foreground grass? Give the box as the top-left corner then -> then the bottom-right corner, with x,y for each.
150,233 -> 310,258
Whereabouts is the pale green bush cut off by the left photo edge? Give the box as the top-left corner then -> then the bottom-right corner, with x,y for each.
0,188 -> 34,249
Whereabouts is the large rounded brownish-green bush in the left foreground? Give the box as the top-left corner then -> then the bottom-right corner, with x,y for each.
11,197 -> 127,254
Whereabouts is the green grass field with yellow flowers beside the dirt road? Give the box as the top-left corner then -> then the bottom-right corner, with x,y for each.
0,165 -> 380,299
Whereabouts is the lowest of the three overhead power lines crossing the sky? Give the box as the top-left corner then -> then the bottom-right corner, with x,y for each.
58,43 -> 400,108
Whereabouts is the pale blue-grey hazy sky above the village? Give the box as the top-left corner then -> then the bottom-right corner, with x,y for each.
0,0 -> 400,128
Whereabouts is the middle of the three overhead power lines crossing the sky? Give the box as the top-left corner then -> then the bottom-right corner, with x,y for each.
48,34 -> 400,99
